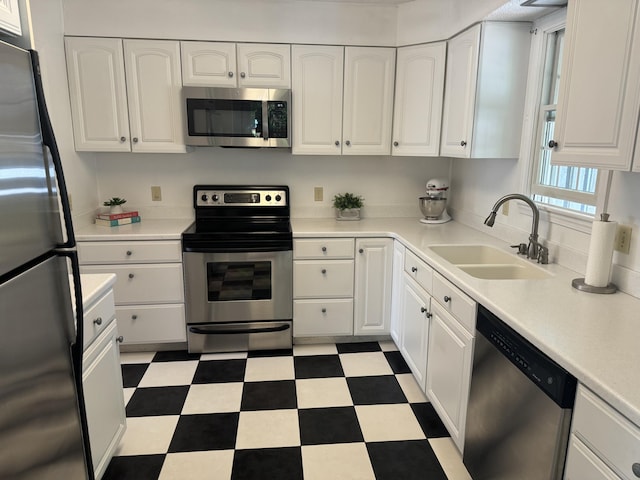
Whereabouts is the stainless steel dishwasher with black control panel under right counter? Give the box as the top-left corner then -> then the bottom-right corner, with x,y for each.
463,305 -> 576,480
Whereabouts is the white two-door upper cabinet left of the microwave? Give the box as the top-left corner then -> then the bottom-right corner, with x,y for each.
65,37 -> 187,153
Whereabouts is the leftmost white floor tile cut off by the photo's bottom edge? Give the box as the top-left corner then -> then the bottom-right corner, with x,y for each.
159,450 -> 233,480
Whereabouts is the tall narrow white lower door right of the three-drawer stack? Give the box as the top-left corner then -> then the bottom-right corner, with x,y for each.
354,238 -> 393,335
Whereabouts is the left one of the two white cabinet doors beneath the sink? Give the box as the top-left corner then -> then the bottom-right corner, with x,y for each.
400,275 -> 431,391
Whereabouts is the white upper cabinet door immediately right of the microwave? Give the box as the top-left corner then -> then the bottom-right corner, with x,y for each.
291,45 -> 344,155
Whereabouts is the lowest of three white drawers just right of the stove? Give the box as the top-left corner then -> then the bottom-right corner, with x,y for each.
293,298 -> 353,337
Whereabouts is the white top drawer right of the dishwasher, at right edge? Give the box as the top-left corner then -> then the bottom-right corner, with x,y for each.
572,385 -> 640,480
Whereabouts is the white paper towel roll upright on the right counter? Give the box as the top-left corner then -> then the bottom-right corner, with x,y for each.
584,214 -> 618,287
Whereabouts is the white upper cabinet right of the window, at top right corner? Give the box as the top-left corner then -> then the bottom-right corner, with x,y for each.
552,0 -> 640,170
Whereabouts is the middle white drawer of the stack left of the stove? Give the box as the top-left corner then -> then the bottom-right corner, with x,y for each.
81,263 -> 184,305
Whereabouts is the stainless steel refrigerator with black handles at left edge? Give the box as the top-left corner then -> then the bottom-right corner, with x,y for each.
0,42 -> 93,480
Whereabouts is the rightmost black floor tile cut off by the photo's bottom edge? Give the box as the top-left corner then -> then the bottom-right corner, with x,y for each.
367,440 -> 447,480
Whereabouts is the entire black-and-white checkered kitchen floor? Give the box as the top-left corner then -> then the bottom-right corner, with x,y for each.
103,342 -> 470,480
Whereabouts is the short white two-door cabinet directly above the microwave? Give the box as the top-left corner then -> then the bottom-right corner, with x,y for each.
181,42 -> 291,88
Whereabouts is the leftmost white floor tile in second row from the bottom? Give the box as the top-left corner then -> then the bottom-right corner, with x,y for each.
115,415 -> 180,456
